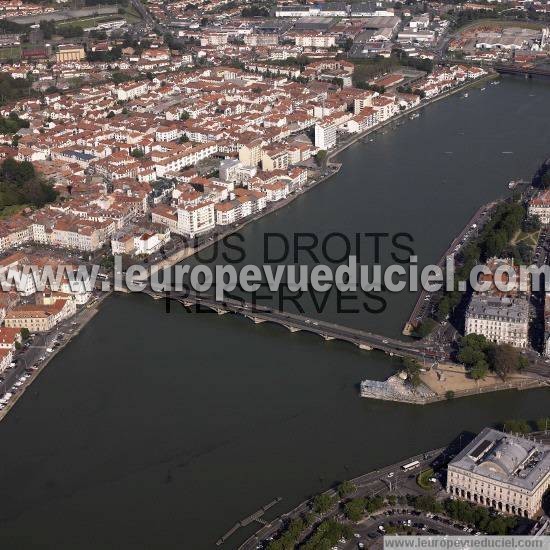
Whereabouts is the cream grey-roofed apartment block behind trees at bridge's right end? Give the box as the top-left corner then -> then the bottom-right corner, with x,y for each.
465,294 -> 529,348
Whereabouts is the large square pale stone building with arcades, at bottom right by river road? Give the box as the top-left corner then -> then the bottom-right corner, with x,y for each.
447,428 -> 550,518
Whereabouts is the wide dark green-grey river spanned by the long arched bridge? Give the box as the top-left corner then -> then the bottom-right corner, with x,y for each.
0,75 -> 550,550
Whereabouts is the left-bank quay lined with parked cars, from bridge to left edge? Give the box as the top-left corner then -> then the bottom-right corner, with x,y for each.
0,292 -> 112,422
